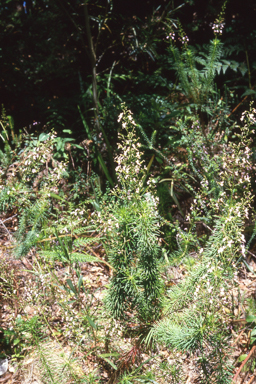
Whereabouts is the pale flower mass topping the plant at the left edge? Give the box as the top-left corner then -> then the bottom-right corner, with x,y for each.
0,133 -> 67,210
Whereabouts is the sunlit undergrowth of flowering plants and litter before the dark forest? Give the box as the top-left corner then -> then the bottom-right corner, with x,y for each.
0,9 -> 256,384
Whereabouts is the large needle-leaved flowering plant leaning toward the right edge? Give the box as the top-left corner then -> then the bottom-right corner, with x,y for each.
152,109 -> 255,384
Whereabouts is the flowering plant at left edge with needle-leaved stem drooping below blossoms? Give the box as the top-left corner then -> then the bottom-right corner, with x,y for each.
0,132 -> 77,257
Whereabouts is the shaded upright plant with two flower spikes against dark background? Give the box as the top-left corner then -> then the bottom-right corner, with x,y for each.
159,2 -> 233,134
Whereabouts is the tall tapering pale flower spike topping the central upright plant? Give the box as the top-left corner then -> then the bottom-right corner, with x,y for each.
95,108 -> 159,234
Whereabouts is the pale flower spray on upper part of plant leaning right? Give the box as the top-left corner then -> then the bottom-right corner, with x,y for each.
186,108 -> 255,264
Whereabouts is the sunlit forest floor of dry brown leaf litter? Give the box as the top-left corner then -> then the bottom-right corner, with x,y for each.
0,218 -> 256,384
